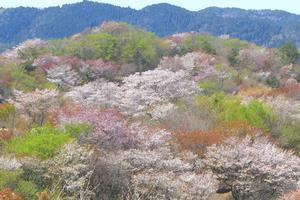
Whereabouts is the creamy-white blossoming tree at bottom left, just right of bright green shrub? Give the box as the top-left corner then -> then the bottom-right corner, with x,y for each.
42,143 -> 95,199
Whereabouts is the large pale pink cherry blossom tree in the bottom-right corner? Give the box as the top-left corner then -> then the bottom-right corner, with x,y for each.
205,137 -> 300,199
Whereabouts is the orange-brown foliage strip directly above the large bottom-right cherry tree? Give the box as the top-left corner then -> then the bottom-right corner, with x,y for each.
174,121 -> 263,155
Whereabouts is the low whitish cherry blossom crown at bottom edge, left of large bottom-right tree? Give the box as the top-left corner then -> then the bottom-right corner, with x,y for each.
133,172 -> 217,200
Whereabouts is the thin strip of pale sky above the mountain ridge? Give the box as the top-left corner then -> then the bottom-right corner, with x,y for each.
0,0 -> 300,14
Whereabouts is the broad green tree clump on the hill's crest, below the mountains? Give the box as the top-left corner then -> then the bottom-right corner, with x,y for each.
50,25 -> 168,71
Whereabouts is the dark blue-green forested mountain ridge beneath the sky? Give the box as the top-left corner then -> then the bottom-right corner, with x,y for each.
0,1 -> 300,47
